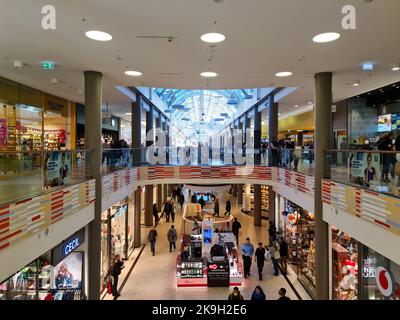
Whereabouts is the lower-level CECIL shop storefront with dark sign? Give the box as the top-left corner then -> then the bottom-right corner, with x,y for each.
0,229 -> 86,300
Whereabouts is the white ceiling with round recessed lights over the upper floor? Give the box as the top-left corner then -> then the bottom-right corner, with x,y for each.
0,0 -> 400,121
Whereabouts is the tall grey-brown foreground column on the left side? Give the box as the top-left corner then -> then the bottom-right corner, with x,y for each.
85,71 -> 103,300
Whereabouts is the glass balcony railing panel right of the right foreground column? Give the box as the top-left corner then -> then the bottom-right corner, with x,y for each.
325,150 -> 400,197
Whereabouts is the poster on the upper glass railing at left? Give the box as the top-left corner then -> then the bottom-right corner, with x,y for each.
44,151 -> 71,187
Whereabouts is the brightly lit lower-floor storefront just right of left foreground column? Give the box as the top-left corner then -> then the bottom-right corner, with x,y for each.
101,201 -> 134,289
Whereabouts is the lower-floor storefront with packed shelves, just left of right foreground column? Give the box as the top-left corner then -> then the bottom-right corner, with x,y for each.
278,200 -> 315,297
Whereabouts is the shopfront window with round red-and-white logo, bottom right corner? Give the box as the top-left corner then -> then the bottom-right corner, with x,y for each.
360,246 -> 400,300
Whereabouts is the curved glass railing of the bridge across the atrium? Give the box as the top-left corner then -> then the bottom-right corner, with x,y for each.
102,147 -> 314,175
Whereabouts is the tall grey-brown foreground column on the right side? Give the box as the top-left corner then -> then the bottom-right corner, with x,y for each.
314,72 -> 332,300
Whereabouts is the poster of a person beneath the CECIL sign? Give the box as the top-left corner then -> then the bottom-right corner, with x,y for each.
53,252 -> 83,290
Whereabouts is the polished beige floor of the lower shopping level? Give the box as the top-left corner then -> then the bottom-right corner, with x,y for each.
119,191 -> 309,300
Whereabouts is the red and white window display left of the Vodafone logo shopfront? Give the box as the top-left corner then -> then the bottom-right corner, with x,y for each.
332,227 -> 358,300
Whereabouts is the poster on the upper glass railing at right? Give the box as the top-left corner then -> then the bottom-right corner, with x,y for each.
349,152 -> 381,186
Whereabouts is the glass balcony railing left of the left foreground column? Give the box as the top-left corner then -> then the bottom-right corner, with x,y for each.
0,150 -> 93,204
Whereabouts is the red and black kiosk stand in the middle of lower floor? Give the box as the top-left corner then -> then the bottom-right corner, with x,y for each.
176,204 -> 243,287
